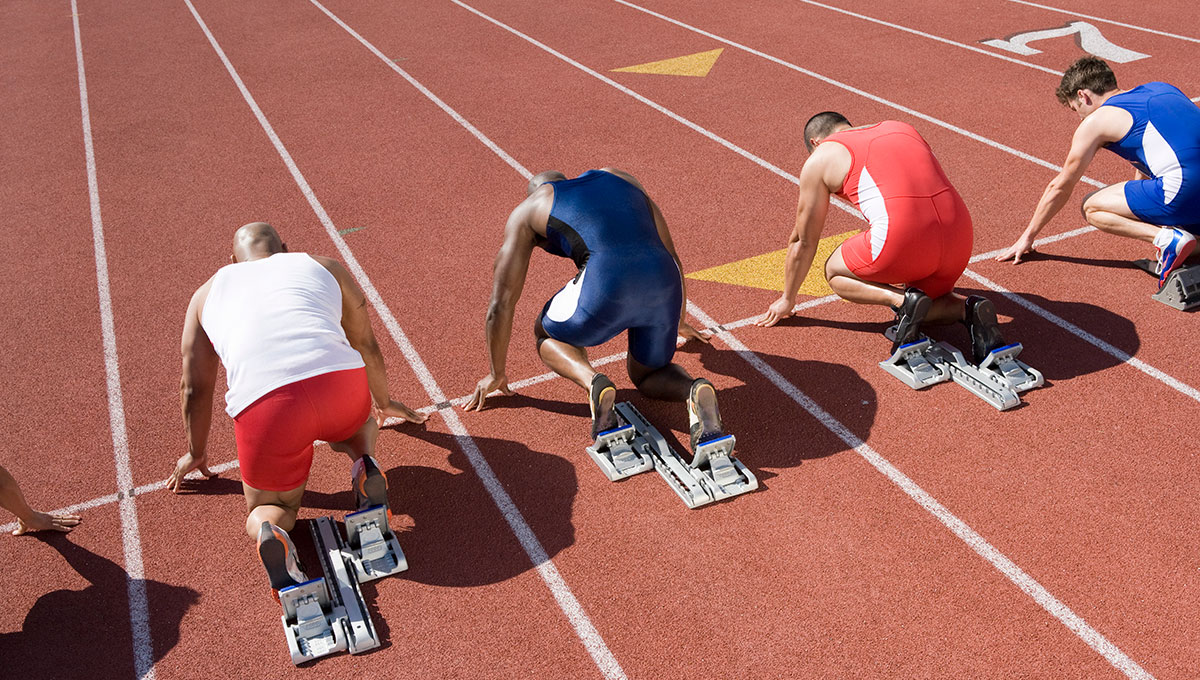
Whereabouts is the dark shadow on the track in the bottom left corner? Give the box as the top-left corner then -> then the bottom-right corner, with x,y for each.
0,534 -> 199,680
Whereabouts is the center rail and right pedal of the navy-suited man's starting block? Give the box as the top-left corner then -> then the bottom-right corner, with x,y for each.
617,402 -> 758,509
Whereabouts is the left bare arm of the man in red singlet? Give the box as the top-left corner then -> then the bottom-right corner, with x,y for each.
756,149 -> 840,326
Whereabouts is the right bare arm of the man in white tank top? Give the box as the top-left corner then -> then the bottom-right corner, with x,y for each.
313,257 -> 428,426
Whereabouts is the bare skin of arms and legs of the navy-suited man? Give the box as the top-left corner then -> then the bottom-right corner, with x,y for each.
463,168 -> 709,410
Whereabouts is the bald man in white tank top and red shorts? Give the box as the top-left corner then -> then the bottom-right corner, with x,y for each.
167,222 -> 427,590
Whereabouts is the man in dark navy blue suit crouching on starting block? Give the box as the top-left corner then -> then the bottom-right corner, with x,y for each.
466,168 -> 722,460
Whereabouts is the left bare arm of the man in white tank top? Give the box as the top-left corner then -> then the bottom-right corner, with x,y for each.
167,279 -> 221,492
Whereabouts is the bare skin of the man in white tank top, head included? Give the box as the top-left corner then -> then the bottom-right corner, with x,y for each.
167,222 -> 428,537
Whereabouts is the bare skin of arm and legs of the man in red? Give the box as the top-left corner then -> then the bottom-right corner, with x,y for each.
755,124 -> 965,327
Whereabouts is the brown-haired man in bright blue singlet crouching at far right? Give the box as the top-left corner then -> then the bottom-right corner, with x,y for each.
996,56 -> 1200,288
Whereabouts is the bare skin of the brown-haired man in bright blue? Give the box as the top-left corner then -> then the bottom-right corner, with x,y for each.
996,89 -> 1137,264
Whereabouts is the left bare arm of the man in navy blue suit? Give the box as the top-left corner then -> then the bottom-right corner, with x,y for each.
463,199 -> 536,411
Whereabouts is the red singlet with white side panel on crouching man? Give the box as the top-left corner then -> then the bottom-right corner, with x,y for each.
824,121 -> 973,297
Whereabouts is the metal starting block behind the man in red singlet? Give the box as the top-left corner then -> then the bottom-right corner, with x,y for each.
880,337 -> 1045,411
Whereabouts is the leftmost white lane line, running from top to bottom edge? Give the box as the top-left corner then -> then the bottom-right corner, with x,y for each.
71,0 -> 155,680
